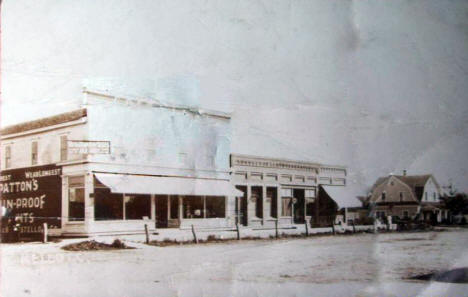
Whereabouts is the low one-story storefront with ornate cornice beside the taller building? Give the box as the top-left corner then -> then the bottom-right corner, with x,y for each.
230,154 -> 347,228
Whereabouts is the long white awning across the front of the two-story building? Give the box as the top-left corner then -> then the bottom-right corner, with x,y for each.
95,173 -> 244,197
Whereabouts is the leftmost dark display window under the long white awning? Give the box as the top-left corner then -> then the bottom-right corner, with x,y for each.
94,188 -> 123,221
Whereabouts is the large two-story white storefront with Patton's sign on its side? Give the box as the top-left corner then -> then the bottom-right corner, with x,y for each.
0,91 -> 242,236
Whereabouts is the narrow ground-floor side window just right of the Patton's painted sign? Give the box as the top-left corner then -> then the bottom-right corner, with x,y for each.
68,176 -> 85,221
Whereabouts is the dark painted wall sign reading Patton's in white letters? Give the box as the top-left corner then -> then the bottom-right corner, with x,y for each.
0,165 -> 62,234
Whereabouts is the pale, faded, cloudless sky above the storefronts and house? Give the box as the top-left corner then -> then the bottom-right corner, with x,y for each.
1,0 -> 468,195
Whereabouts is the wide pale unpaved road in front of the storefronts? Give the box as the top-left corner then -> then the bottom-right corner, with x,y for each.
0,230 -> 468,297
